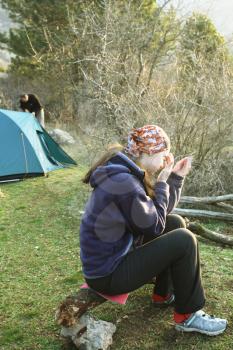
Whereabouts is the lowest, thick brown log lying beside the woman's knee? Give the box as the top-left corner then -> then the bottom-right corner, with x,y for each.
187,222 -> 233,247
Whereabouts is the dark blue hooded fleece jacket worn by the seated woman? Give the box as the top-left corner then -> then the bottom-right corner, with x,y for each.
80,152 -> 183,278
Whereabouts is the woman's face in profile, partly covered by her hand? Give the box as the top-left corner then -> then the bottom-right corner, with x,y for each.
140,150 -> 170,175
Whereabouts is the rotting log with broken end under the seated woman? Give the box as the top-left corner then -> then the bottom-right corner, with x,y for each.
55,289 -> 106,327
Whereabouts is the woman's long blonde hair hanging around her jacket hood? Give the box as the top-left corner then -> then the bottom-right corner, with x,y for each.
82,143 -> 155,199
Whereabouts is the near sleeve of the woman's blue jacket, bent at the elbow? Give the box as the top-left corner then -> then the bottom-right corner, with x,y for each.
119,182 -> 169,238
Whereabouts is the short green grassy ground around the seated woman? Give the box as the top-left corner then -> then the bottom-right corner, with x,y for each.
0,167 -> 233,350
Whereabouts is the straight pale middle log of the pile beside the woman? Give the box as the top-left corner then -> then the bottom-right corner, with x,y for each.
172,208 -> 233,221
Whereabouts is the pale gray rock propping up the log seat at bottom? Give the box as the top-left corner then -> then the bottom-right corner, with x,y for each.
61,314 -> 116,350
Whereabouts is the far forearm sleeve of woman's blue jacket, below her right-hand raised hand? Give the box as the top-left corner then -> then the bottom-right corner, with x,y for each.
167,173 -> 184,214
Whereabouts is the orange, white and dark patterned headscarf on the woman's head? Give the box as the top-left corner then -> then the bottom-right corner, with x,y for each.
125,125 -> 170,157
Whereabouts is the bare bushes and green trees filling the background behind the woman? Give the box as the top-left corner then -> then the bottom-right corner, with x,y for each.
1,0 -> 233,194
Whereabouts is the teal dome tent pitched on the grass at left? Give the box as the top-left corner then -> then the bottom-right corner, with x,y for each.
0,109 -> 76,181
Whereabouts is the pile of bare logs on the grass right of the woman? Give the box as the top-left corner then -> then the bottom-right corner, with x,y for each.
173,194 -> 233,246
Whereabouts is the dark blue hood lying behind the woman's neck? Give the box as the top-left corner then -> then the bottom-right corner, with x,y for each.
90,152 -> 144,188
